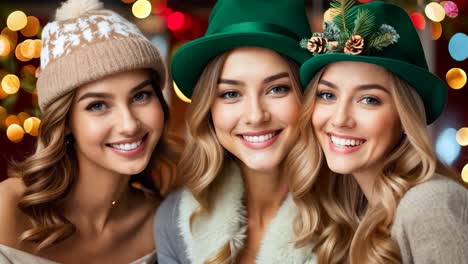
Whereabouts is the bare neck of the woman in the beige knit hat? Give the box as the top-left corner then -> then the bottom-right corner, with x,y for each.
65,164 -> 131,233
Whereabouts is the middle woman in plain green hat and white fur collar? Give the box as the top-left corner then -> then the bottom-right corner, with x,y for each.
154,0 -> 315,264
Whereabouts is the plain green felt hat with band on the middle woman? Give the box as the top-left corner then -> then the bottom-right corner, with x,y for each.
171,0 -> 311,98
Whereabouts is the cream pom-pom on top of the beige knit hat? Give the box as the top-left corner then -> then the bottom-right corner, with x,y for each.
55,0 -> 103,21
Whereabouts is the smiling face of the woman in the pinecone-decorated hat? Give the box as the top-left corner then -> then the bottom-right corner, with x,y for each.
312,62 -> 402,176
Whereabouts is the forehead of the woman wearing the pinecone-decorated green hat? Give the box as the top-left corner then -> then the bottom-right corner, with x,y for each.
321,61 -> 393,87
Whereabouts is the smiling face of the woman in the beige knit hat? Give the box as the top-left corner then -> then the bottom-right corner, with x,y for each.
69,70 -> 164,175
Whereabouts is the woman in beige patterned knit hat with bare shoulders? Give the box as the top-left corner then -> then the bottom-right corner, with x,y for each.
0,0 -> 177,264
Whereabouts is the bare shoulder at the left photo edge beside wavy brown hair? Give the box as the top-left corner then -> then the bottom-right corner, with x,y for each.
0,178 -> 26,246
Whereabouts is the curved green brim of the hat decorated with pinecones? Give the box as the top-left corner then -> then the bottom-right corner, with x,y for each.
300,53 -> 447,124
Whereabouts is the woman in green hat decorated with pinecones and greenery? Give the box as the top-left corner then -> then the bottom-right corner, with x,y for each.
289,1 -> 468,263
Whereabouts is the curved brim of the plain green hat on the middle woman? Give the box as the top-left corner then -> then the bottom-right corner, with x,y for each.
171,32 -> 310,98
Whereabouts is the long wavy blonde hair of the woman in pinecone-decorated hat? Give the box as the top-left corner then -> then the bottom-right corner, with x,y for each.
287,66 -> 466,264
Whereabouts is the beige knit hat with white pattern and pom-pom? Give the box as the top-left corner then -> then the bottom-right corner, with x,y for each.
37,0 -> 167,110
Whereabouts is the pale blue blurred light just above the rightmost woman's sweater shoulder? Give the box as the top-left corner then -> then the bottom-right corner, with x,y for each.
435,128 -> 461,166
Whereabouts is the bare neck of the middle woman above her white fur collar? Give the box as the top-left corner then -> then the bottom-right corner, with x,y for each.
241,168 -> 288,226
